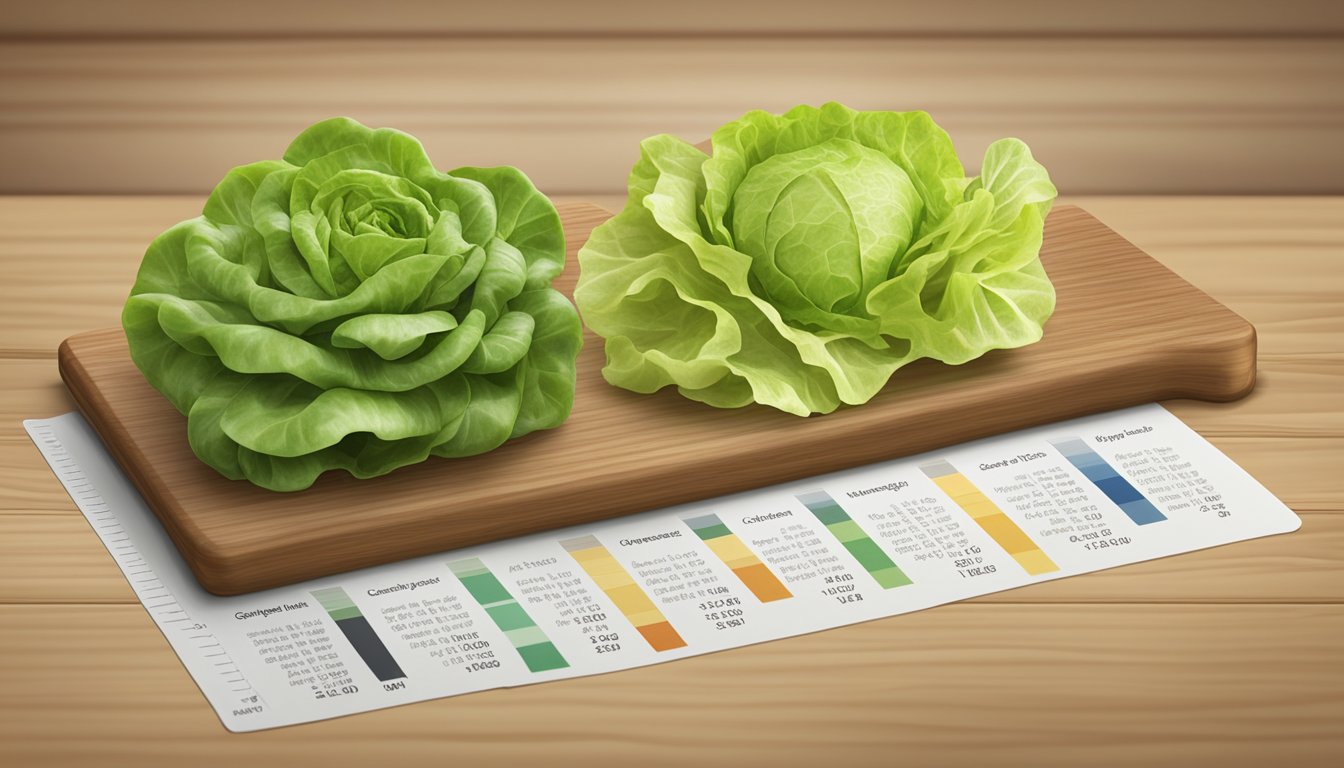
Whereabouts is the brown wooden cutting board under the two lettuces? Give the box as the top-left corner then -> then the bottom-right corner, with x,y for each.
59,204 -> 1255,594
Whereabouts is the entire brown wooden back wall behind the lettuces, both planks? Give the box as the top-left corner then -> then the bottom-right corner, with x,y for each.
0,0 -> 1344,195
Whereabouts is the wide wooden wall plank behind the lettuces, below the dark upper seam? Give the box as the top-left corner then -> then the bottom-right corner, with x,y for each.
0,38 -> 1344,195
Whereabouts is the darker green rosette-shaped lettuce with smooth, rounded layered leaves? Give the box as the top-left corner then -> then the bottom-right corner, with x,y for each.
122,118 -> 581,491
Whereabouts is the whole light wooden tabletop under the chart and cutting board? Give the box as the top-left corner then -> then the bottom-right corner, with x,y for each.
0,196 -> 1344,767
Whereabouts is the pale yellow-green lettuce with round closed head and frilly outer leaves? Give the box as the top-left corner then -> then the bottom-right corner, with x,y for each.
574,104 -> 1055,416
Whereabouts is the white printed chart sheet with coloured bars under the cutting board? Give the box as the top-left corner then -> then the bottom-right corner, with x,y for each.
26,405 -> 1300,730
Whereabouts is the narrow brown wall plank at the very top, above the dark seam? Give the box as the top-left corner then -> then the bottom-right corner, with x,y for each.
0,0 -> 1344,39
